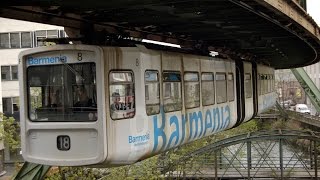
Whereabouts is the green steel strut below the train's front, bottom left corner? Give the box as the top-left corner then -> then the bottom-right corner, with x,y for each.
14,162 -> 51,180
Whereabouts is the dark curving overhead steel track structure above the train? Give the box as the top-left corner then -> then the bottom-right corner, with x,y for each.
0,0 -> 320,69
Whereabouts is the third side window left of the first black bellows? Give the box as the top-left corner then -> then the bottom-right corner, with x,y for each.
201,73 -> 214,106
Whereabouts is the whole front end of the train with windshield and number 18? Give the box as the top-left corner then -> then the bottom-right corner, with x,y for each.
19,45 -> 107,166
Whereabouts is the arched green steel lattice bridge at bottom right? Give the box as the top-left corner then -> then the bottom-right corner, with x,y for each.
162,130 -> 320,179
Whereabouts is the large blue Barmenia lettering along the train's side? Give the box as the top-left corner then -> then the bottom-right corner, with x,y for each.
152,105 -> 231,153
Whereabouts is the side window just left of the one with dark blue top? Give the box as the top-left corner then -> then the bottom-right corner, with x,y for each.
144,70 -> 160,116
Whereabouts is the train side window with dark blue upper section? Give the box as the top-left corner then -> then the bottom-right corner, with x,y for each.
163,71 -> 182,112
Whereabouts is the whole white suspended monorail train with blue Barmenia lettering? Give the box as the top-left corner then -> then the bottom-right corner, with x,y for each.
19,45 -> 276,167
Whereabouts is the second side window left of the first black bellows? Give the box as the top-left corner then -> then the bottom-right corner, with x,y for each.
216,73 -> 227,104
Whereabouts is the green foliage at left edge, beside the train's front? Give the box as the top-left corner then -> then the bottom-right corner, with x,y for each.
0,114 -> 20,152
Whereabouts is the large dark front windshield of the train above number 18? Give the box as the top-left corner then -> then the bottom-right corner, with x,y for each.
27,63 -> 98,122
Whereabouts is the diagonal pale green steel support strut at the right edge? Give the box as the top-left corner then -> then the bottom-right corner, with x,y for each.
291,68 -> 320,112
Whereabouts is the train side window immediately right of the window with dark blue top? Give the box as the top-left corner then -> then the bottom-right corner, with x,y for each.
184,72 -> 200,108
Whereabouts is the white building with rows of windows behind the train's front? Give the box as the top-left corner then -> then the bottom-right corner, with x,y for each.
0,18 -> 66,169
